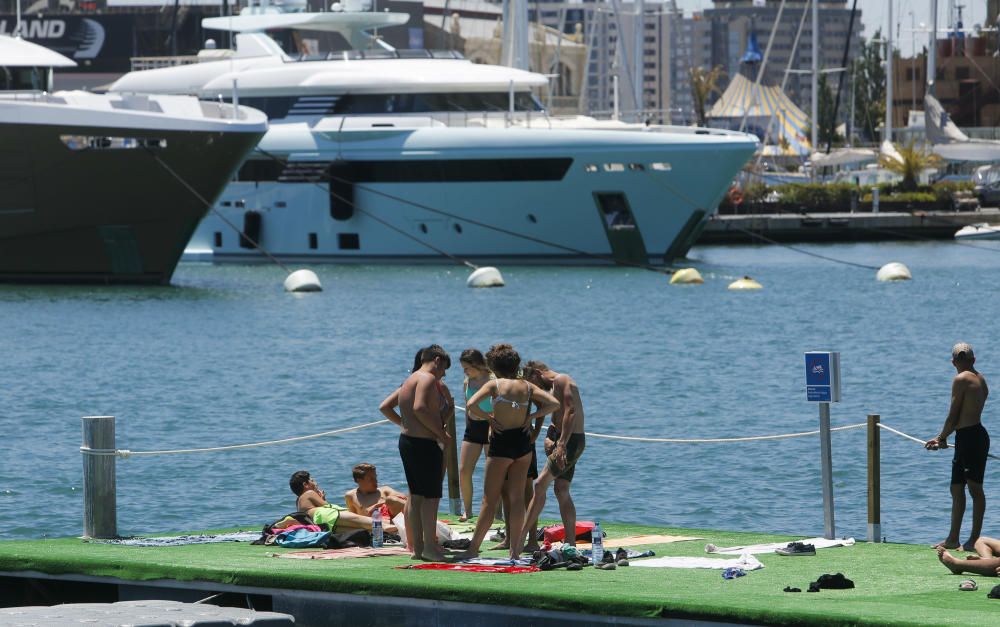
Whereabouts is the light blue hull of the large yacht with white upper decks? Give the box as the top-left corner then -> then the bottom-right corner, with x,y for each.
188,125 -> 756,264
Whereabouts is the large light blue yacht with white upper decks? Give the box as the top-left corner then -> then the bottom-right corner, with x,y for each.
111,4 -> 757,263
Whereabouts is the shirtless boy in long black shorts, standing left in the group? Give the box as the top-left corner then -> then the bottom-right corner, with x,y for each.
379,345 -> 451,562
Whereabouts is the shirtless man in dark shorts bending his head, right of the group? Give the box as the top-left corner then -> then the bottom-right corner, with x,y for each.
521,361 -> 587,545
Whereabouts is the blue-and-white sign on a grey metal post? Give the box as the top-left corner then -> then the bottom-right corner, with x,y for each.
806,351 -> 840,540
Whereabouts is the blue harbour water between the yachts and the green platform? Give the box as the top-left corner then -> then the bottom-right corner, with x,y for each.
0,242 -> 1000,542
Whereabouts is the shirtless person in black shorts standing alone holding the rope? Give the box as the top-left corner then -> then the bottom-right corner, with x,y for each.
924,342 -> 990,561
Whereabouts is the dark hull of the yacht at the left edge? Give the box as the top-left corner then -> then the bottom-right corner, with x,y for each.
0,117 -> 263,284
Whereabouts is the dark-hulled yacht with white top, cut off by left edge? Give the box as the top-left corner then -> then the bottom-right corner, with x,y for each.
0,35 -> 267,284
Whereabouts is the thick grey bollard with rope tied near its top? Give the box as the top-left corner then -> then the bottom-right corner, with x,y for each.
80,416 -> 118,538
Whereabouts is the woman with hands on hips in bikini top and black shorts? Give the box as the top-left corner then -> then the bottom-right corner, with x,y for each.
465,344 -> 559,559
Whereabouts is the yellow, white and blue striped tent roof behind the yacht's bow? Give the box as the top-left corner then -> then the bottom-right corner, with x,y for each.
708,74 -> 812,156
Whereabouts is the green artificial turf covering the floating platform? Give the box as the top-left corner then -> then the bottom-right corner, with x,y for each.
0,524 -> 1000,626
